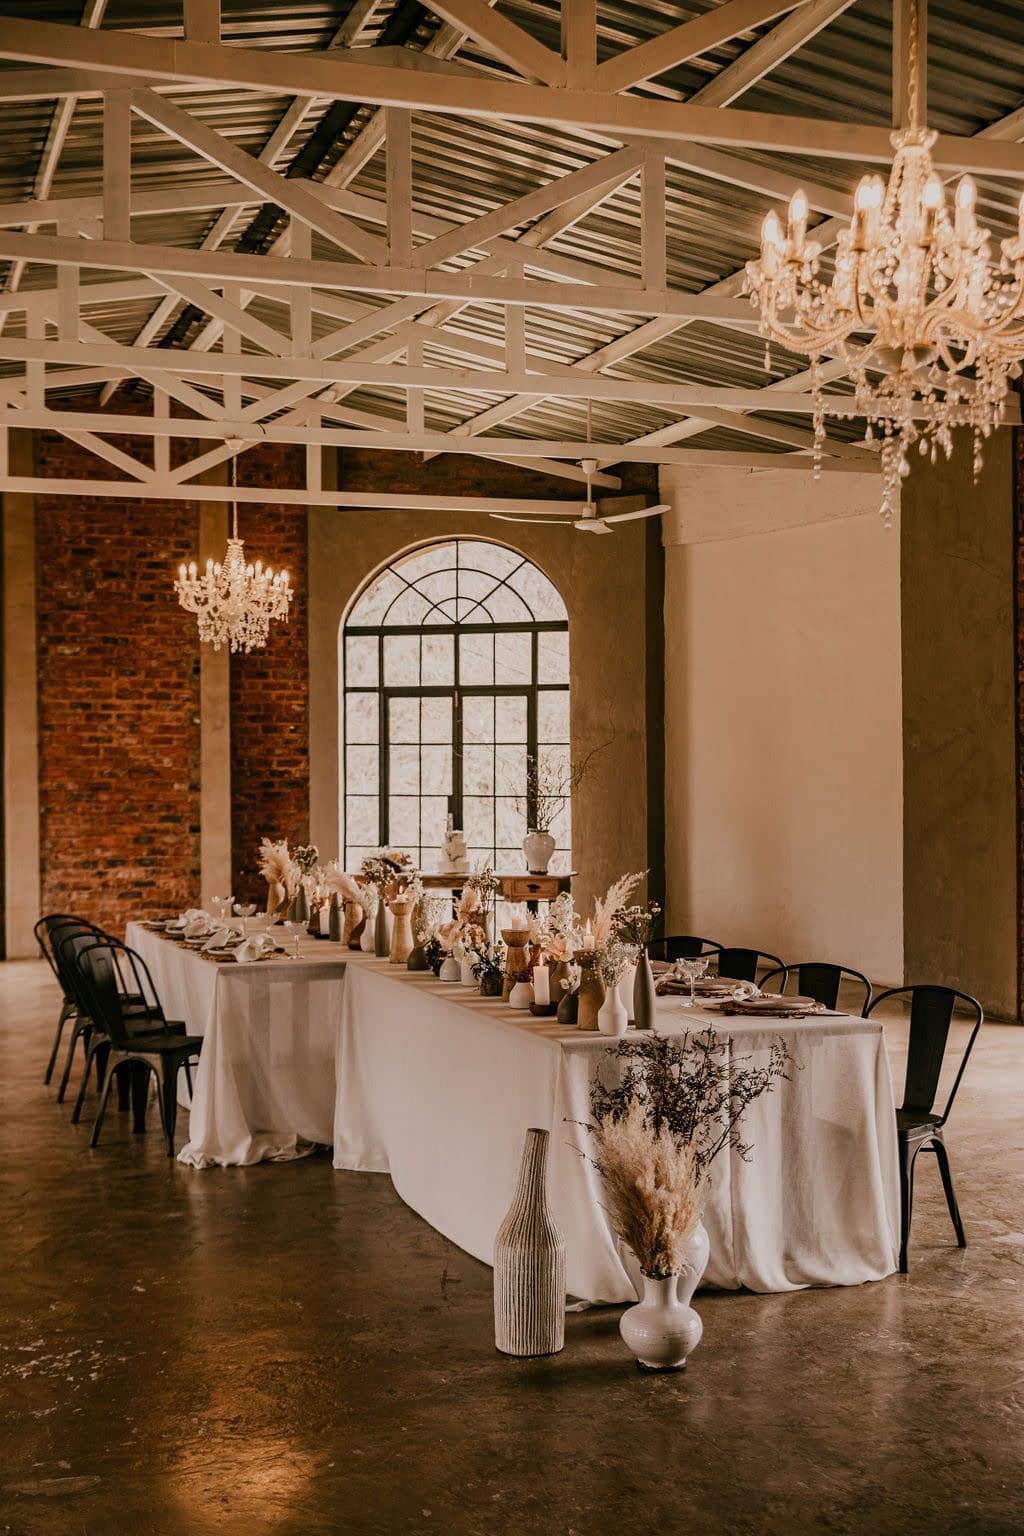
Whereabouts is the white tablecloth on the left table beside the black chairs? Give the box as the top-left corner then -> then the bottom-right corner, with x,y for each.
127,923 -> 345,1167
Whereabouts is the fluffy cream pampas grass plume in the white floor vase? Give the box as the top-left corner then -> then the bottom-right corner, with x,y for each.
593,1100 -> 703,1279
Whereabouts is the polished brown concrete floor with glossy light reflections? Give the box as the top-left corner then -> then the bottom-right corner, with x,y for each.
0,962 -> 1024,1536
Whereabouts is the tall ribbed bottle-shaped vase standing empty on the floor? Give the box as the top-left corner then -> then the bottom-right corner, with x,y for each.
494,1127 -> 565,1355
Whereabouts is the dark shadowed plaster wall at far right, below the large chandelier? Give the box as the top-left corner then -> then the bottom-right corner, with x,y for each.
903,429 -> 1016,1017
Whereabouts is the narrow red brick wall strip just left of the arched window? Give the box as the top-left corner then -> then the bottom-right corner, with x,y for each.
230,445 -> 309,900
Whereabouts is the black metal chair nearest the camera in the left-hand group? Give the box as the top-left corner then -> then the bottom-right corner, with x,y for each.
74,938 -> 203,1157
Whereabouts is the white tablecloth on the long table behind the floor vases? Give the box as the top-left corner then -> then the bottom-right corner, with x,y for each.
335,957 -> 900,1301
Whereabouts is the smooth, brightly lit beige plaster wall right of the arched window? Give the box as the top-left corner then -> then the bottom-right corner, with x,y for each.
662,468 -> 903,982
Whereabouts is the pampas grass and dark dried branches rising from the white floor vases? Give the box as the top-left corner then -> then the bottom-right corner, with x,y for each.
586,1028 -> 789,1279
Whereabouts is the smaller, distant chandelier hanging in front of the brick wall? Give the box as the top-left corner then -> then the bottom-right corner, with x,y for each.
173,455 -> 292,653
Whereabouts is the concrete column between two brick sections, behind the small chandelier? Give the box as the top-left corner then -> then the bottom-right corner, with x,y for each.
198,494 -> 232,902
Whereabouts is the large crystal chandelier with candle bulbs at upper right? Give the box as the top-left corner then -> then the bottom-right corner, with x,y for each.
746,0 -> 1024,525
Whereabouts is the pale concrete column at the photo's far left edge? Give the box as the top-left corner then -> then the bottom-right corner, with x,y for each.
3,432 -> 41,960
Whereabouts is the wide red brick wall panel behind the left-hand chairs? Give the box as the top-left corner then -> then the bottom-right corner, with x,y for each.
35,433 -> 200,931
